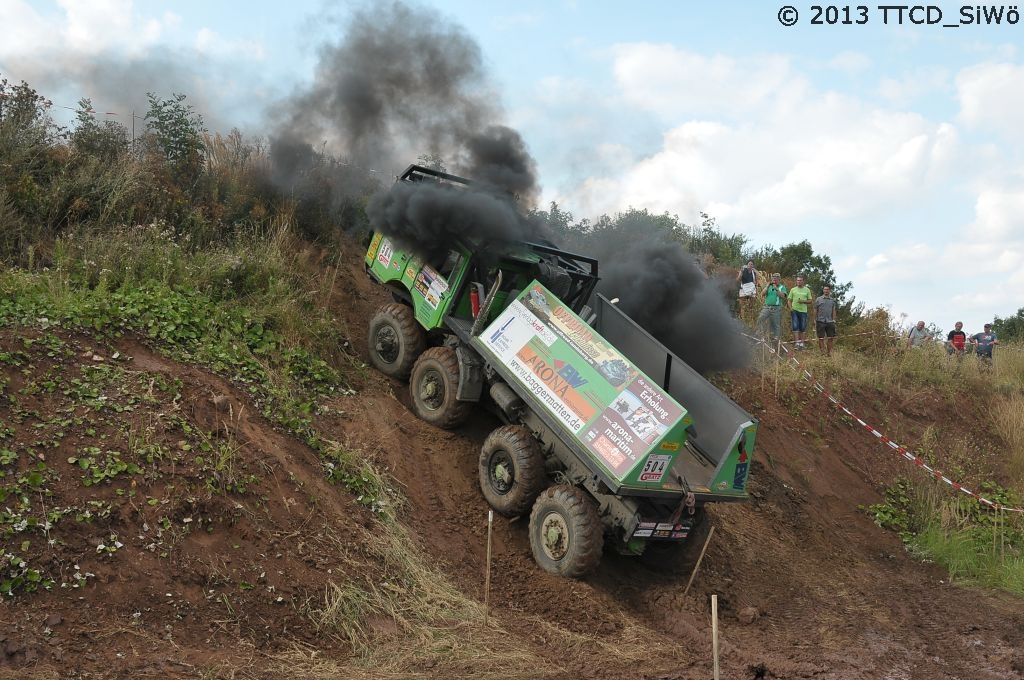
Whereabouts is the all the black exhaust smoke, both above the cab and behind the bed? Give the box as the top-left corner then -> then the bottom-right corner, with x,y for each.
272,2 -> 746,373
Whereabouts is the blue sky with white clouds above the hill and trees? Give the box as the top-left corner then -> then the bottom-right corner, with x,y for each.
0,0 -> 1024,333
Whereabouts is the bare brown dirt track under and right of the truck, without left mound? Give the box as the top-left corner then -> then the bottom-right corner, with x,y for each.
335,251 -> 1024,679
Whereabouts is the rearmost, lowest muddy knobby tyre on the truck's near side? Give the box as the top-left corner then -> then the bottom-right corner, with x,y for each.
529,484 -> 604,579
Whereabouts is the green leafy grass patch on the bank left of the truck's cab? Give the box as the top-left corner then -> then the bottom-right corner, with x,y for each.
0,220 -> 348,438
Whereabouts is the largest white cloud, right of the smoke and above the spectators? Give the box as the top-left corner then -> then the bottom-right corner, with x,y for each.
563,55 -> 958,231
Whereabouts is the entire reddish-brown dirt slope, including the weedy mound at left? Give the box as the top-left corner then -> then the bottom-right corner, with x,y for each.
0,246 -> 1024,680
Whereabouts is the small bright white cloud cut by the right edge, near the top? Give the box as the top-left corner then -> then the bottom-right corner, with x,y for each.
956,63 -> 1024,139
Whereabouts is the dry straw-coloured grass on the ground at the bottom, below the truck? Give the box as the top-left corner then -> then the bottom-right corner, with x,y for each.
284,448 -> 564,680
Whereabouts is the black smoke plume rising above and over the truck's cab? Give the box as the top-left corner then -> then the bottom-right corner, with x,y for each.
272,2 -> 538,249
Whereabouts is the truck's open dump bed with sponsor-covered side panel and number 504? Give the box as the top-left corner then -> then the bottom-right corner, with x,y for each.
471,282 -> 756,501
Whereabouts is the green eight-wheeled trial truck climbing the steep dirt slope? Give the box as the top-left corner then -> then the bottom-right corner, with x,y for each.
366,166 -> 757,577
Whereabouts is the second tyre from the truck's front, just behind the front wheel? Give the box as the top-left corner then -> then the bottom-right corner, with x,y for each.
409,347 -> 473,430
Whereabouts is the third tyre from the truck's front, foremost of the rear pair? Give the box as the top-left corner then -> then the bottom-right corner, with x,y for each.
479,425 -> 548,517
